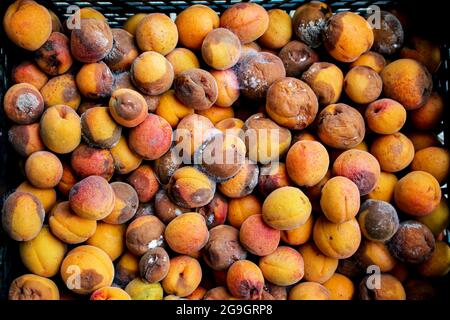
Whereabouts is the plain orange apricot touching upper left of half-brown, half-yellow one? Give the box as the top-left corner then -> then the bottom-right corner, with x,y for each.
175,4 -> 220,50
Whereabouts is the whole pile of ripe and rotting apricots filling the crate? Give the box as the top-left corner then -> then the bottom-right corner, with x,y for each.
2,0 -> 450,300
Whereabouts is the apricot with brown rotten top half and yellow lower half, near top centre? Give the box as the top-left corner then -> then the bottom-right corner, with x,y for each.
201,28 -> 241,70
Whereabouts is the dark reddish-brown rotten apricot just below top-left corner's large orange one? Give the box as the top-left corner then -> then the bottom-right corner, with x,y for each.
34,32 -> 73,76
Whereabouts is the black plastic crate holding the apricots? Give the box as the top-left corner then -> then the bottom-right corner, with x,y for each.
0,0 -> 450,300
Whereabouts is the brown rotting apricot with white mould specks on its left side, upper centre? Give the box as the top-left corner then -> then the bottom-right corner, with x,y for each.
237,52 -> 286,100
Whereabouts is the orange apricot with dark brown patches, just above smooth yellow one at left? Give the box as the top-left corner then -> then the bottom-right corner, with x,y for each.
41,74 -> 80,110
